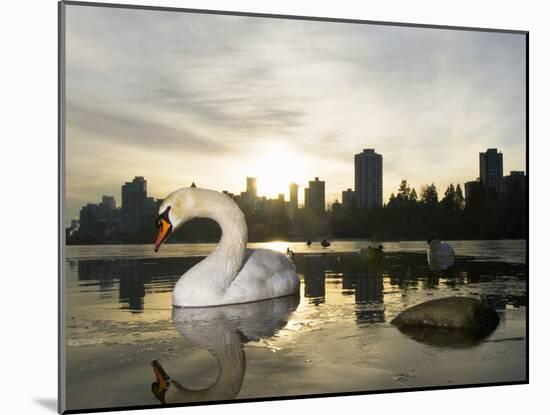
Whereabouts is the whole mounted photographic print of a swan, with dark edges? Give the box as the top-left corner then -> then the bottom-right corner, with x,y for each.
59,1 -> 528,413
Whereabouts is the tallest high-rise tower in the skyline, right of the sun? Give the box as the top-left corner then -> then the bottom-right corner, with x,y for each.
355,148 -> 383,208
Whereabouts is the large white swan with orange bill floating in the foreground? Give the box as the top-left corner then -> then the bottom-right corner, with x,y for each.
155,187 -> 300,307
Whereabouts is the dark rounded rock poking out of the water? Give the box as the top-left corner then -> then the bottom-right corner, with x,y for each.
391,297 -> 500,333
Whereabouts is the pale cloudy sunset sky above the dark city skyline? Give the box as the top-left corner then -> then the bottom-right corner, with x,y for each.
66,5 -> 526,224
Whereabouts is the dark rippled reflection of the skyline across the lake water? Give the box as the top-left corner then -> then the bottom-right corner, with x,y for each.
71,253 -> 527,316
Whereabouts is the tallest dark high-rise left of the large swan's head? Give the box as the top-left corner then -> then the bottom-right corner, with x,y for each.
122,176 -> 147,237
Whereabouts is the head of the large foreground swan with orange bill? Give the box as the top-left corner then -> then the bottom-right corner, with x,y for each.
155,187 -> 201,252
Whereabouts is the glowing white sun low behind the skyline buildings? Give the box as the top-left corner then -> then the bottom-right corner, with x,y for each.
251,145 -> 306,200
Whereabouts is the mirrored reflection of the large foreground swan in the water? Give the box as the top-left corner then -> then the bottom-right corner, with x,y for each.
151,295 -> 300,404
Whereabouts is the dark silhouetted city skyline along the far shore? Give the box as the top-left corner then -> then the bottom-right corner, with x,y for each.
66,144 -> 527,243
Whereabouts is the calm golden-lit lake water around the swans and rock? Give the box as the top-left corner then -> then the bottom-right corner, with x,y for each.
65,240 -> 528,409
